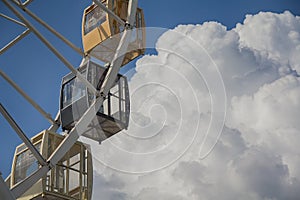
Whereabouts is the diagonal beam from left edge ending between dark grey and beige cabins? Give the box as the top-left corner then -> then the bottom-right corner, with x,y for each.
0,70 -> 56,124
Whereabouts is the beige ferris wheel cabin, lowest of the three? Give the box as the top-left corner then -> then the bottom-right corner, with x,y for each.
9,130 -> 93,200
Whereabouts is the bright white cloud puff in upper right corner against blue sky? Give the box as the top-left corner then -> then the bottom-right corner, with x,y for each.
236,11 -> 300,73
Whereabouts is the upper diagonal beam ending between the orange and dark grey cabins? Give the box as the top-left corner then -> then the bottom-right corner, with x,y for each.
11,3 -> 85,56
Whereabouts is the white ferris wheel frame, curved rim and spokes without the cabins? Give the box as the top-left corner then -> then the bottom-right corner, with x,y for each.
0,0 -> 138,200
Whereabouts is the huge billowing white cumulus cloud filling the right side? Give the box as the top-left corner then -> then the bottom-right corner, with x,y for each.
86,11 -> 300,200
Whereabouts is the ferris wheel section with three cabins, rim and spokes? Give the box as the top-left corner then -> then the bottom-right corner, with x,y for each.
0,0 -> 145,200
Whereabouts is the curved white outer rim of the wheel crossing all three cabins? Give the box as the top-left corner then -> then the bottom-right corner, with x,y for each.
2,0 -> 137,198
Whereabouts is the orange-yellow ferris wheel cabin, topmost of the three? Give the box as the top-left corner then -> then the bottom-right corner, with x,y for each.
82,0 -> 145,65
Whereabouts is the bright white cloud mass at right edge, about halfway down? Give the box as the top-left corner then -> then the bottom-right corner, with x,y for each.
227,75 -> 300,132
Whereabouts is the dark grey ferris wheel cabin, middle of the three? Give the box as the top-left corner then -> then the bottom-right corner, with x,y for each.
60,60 -> 130,143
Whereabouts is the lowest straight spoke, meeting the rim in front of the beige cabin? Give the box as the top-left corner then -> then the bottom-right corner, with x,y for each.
0,103 -> 47,166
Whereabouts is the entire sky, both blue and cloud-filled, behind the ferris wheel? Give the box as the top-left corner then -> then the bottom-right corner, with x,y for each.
0,1 -> 300,200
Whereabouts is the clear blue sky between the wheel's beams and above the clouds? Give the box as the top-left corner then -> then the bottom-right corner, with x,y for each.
0,0 -> 300,181
